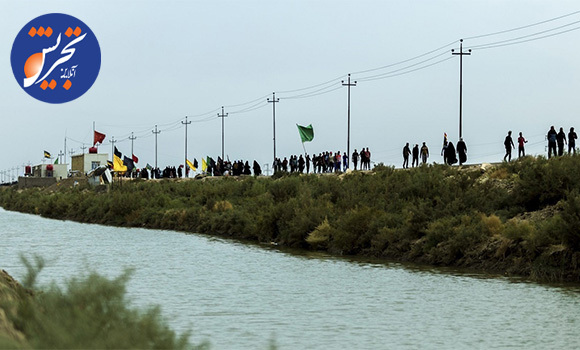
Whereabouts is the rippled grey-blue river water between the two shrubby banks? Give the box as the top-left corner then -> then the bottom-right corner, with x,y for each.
0,209 -> 580,349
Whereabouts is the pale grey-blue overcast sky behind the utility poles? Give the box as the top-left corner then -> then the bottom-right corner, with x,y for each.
0,0 -> 580,176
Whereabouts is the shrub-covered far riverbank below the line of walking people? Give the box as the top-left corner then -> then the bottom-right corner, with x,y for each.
0,157 -> 580,282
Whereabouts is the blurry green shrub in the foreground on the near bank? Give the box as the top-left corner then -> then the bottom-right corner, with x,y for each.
9,258 -> 207,349
